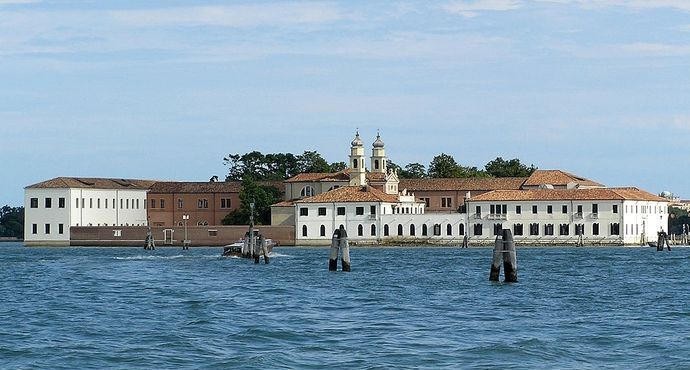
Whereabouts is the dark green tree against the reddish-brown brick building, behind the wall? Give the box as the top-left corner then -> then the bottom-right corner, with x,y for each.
221,176 -> 281,225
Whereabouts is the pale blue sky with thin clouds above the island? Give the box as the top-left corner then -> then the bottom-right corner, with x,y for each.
0,0 -> 690,206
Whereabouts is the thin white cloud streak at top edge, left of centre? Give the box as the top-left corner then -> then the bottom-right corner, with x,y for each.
111,3 -> 345,28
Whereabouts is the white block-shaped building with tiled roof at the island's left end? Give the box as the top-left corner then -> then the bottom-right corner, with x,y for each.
24,177 -> 154,245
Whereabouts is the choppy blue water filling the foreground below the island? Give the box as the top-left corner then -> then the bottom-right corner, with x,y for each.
0,244 -> 690,369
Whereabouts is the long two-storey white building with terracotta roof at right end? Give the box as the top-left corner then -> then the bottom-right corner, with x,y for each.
467,188 -> 668,245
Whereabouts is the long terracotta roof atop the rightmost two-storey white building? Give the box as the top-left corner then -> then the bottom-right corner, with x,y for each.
469,188 -> 668,202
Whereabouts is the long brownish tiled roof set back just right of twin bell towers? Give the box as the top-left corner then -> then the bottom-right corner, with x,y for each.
398,177 -> 527,192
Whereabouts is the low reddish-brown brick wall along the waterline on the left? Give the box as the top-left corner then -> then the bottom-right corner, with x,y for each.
70,225 -> 295,247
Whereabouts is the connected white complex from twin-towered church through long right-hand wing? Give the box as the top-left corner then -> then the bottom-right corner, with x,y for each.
286,133 -> 668,245
